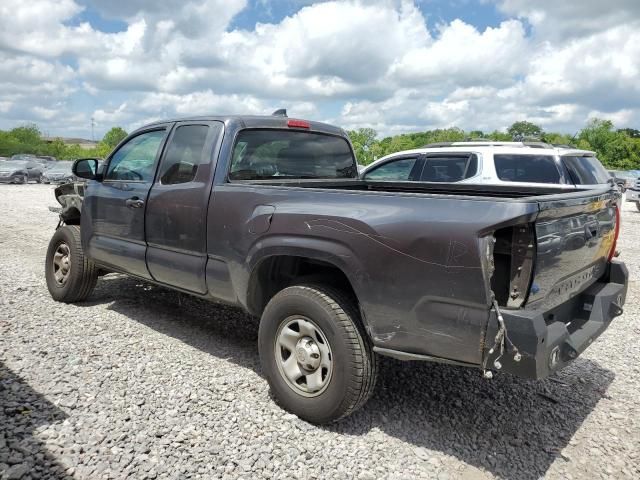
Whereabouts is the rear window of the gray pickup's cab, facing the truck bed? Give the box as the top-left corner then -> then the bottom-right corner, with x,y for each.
229,130 -> 358,180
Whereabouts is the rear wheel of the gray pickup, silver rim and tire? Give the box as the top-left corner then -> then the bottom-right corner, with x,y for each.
258,285 -> 377,423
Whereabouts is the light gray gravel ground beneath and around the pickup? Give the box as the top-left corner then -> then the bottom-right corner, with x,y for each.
0,185 -> 640,480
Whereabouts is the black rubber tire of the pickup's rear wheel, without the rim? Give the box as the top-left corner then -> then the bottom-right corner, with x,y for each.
258,284 -> 378,424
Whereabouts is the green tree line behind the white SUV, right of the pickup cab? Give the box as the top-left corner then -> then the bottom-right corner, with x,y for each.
348,119 -> 640,170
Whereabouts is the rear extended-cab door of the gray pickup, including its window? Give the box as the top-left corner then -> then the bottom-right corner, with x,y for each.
146,121 -> 223,293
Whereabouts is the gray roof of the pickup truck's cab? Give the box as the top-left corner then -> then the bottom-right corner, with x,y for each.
138,115 -> 346,136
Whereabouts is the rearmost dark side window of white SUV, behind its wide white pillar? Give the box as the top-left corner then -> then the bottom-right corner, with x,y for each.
493,155 -> 560,183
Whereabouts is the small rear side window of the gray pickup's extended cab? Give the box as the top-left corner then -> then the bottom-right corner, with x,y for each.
160,125 -> 209,185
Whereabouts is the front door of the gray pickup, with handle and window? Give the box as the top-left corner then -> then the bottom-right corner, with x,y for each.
81,124 -> 171,278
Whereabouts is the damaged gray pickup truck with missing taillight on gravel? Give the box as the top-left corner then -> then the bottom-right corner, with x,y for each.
46,115 -> 627,423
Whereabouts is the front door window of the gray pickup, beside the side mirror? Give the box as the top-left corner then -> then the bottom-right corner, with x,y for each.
105,129 -> 165,182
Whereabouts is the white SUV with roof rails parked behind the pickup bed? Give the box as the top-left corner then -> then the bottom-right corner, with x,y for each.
361,141 -> 611,188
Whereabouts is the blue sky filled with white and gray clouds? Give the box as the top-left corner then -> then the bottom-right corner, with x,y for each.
0,0 -> 640,139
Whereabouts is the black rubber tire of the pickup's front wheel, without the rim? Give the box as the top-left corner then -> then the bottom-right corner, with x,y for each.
45,225 -> 98,303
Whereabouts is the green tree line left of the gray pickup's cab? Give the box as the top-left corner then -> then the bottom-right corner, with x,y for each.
0,124 -> 127,160
